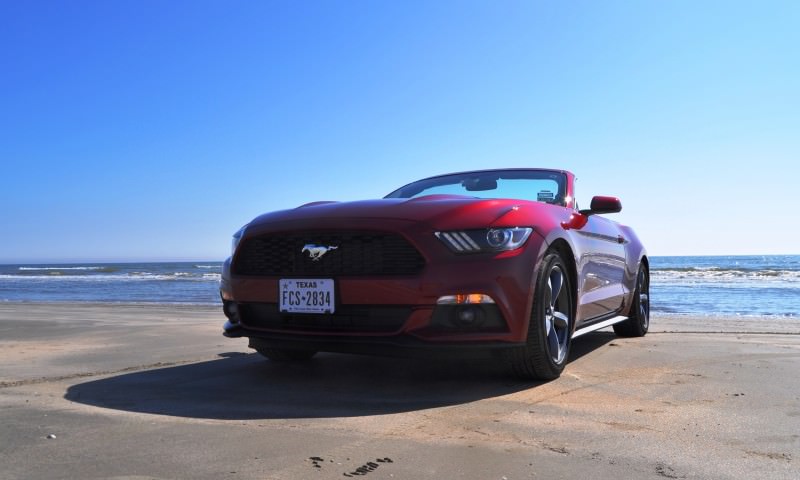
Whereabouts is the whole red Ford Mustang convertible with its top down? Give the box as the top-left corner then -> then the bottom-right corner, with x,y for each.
220,169 -> 650,379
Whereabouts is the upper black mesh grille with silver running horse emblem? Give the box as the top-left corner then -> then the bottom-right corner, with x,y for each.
233,232 -> 425,277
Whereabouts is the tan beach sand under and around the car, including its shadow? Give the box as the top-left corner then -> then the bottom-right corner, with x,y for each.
0,304 -> 800,480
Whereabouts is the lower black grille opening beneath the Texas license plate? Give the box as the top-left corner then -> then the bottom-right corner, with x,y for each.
238,303 -> 411,333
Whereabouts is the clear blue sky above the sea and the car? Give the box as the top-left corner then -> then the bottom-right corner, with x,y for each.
0,0 -> 800,263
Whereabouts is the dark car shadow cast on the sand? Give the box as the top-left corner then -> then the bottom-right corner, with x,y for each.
65,332 -> 615,420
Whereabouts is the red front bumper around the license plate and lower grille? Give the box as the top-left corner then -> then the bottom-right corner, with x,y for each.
220,222 -> 544,346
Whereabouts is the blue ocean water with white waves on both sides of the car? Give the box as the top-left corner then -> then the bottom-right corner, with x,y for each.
0,255 -> 800,318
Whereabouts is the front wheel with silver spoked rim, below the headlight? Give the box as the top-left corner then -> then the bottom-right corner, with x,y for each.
509,252 -> 575,380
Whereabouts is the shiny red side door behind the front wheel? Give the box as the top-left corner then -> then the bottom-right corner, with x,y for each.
575,215 -> 625,321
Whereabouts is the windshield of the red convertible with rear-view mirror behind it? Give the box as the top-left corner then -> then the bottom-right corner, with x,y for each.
386,170 -> 567,206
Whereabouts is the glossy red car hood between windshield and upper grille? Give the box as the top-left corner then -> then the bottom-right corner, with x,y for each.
250,195 -> 565,229
